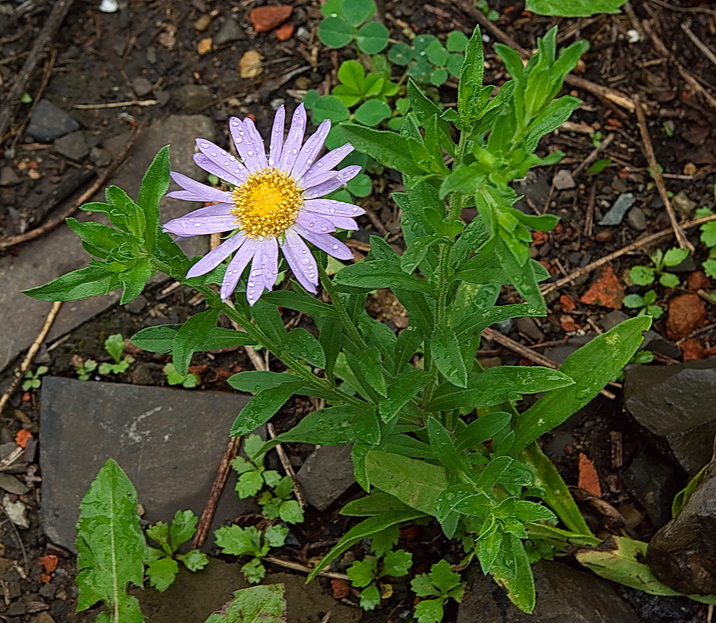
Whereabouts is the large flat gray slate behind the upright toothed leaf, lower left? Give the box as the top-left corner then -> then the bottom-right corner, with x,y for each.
40,377 -> 252,550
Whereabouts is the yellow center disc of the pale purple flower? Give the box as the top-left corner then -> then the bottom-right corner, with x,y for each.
231,168 -> 303,238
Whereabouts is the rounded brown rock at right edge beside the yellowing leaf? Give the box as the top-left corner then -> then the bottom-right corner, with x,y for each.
646,462 -> 716,595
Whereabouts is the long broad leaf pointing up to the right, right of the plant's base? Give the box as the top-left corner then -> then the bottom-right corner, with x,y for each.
511,316 -> 651,454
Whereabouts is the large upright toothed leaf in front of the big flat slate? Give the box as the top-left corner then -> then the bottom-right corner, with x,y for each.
76,459 -> 146,623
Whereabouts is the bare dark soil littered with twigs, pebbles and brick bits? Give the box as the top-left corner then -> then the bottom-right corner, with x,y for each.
0,0 -> 716,623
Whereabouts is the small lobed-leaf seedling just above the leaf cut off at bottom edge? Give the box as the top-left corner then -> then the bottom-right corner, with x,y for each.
214,525 -> 288,584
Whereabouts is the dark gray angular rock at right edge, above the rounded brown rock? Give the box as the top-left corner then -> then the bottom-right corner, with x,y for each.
624,359 -> 716,475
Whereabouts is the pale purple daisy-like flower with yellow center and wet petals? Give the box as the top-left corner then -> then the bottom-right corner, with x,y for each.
164,104 -> 364,305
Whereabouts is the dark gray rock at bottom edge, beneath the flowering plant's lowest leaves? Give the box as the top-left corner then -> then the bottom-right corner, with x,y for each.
457,560 -> 639,623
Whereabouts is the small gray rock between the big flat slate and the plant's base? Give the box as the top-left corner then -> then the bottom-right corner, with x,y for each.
296,445 -> 355,511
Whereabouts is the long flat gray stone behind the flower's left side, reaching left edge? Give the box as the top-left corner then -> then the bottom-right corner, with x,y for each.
0,115 -> 215,370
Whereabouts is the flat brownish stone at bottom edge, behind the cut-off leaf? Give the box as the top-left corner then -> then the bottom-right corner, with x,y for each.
133,558 -> 362,623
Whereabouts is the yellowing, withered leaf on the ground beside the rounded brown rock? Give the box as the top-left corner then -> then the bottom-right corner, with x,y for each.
575,536 -> 716,604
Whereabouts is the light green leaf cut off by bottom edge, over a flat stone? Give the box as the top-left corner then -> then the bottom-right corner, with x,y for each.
206,584 -> 288,623
